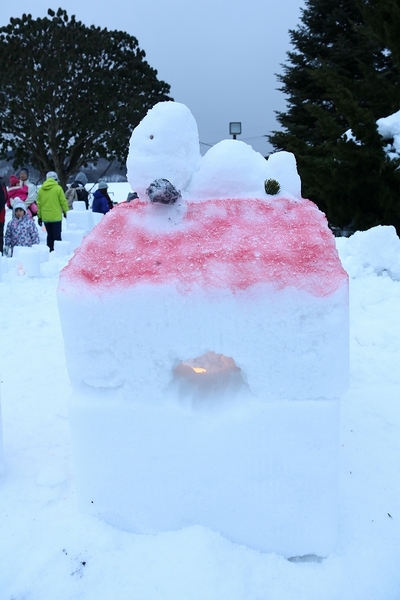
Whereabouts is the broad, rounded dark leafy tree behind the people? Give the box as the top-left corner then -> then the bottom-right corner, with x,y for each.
0,8 -> 171,184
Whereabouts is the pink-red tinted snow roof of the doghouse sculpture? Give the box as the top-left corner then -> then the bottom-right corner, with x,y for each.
60,198 -> 347,296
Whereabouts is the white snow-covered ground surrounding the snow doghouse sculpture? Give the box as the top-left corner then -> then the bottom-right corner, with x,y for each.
0,205 -> 400,600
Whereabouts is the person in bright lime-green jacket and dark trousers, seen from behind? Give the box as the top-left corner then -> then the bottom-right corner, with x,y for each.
37,171 -> 68,252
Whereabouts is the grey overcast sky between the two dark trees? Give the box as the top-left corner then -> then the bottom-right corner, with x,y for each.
0,0 -> 304,155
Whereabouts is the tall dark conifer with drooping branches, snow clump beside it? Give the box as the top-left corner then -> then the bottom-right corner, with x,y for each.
269,0 -> 400,231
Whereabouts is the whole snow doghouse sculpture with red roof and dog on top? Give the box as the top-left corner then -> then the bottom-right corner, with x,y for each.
58,102 -> 349,557
